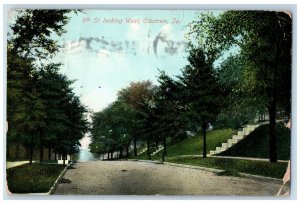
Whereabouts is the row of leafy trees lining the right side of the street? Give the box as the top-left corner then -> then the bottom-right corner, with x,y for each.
90,11 -> 292,162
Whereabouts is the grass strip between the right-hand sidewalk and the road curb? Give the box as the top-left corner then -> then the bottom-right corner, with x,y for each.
166,157 -> 288,179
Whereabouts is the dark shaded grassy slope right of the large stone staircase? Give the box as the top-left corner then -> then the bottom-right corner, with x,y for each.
219,123 -> 291,160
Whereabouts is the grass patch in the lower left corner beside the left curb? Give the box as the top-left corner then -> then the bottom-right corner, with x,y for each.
6,163 -> 65,193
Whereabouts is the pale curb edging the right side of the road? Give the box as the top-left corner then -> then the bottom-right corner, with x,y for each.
131,160 -> 282,184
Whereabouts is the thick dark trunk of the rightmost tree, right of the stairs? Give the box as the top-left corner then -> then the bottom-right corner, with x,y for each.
269,99 -> 277,162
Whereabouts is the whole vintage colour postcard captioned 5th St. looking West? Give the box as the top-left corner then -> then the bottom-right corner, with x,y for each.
6,9 -> 294,197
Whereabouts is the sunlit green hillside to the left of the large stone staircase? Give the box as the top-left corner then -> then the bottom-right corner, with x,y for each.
138,129 -> 235,160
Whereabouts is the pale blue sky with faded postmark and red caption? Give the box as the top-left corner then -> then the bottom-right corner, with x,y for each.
53,10 -> 202,112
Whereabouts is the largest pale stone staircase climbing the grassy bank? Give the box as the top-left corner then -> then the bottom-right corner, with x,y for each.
210,124 -> 262,155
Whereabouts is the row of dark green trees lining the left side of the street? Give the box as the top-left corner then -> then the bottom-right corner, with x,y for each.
7,10 -> 88,164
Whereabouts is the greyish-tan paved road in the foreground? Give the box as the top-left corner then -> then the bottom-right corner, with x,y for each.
54,161 -> 280,196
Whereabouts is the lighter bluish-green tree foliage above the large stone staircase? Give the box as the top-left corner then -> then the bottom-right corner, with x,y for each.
216,54 -> 266,129
